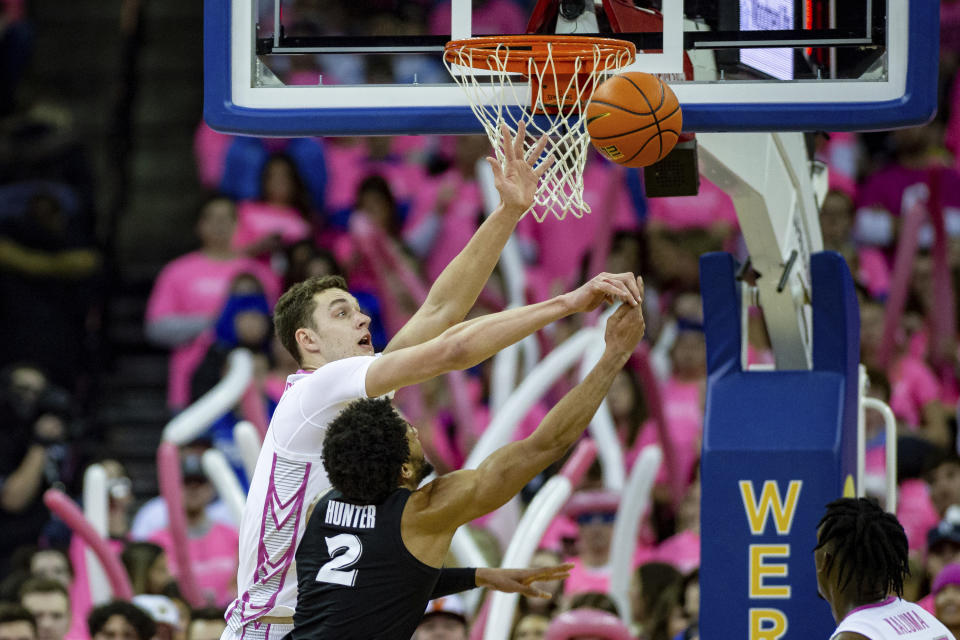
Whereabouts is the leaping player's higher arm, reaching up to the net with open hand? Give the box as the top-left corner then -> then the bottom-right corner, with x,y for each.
384,122 -> 553,353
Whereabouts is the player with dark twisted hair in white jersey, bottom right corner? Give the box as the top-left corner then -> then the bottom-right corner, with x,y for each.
813,498 -> 955,640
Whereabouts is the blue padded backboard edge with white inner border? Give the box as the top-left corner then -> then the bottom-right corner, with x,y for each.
204,0 -> 939,137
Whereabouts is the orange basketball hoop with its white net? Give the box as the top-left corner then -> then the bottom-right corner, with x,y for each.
443,35 -> 636,222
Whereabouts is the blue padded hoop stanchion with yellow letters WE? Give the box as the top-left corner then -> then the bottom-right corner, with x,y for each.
700,252 -> 859,640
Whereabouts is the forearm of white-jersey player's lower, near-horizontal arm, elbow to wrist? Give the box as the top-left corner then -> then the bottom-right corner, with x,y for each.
442,294 -> 575,369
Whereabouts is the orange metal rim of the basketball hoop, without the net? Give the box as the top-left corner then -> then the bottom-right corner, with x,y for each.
443,35 -> 637,74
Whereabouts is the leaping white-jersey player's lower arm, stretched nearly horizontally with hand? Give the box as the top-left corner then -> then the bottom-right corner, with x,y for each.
366,273 -> 641,398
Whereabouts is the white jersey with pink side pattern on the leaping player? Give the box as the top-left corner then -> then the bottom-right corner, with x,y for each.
226,356 -> 377,631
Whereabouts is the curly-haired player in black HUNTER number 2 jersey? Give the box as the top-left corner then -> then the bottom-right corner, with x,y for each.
292,292 -> 644,640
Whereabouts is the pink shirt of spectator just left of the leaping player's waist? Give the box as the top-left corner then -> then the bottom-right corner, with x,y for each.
150,522 -> 240,607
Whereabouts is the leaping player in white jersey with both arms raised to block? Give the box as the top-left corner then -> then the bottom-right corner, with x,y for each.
223,125 -> 640,640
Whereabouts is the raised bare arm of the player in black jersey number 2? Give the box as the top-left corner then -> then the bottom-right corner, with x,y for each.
409,290 -> 644,536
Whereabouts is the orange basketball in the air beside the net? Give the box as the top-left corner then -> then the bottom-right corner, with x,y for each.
586,71 -> 683,167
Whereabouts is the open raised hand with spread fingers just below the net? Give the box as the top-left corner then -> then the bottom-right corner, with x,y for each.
487,120 -> 553,219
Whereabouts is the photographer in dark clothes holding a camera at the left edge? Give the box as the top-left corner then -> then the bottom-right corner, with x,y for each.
0,364 -> 72,575
